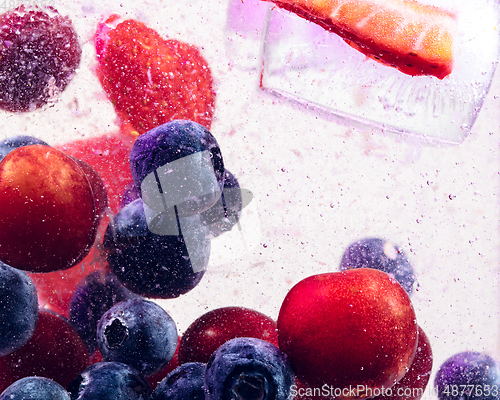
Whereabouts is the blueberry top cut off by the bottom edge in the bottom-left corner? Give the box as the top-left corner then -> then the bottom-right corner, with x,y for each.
0,376 -> 70,400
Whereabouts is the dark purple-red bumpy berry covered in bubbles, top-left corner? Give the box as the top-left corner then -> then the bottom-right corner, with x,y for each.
0,8 -> 82,111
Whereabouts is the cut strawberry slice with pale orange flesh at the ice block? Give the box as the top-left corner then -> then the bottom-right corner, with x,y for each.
268,0 -> 456,79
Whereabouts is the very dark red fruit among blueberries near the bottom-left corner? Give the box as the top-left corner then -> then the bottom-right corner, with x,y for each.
0,310 -> 90,392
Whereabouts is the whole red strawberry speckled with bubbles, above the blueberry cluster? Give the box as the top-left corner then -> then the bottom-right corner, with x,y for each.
94,16 -> 215,135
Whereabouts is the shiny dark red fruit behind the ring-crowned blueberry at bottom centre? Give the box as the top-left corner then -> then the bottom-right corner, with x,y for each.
179,307 -> 278,364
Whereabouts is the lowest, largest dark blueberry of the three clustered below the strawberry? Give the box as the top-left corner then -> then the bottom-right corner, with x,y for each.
103,199 -> 211,298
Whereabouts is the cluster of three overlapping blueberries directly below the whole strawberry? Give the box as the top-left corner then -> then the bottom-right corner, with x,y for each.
103,120 -> 243,298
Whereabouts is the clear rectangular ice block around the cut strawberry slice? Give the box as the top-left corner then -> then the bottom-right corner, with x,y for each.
262,0 -> 500,143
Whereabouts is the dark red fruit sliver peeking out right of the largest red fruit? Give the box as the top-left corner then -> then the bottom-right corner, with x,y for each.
373,326 -> 433,400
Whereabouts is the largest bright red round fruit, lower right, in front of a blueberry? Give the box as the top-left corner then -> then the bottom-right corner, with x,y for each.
278,268 -> 418,398
